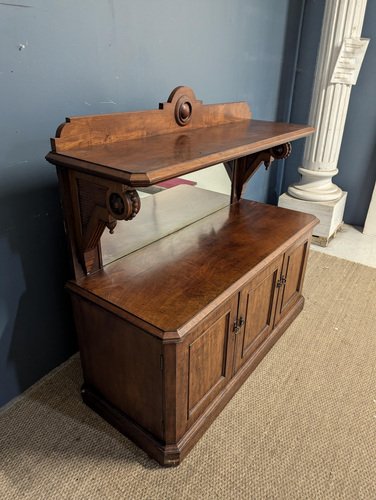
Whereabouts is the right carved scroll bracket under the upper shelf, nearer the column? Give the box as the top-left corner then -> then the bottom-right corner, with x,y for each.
225,142 -> 292,203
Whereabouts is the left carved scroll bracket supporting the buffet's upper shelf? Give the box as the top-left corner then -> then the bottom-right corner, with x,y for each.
71,172 -> 141,274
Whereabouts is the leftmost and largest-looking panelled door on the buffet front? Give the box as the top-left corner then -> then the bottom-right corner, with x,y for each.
177,294 -> 238,435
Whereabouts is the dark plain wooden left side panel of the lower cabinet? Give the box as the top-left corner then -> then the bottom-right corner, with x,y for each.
73,297 -> 163,439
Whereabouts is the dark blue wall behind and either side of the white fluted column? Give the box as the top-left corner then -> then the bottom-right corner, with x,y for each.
281,0 -> 376,226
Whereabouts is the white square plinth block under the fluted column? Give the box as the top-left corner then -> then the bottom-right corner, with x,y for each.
278,191 -> 347,246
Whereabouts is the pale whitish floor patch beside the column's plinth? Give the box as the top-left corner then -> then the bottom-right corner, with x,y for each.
311,224 -> 376,267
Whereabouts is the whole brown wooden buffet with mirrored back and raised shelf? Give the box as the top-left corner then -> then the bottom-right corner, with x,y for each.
46,87 -> 317,466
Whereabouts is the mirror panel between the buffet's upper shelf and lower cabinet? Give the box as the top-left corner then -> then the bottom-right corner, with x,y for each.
101,163 -> 231,265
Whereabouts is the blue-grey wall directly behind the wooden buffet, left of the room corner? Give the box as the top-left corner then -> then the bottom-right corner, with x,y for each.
0,0 -> 303,405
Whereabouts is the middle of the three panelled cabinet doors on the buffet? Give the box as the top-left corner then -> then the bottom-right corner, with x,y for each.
234,256 -> 282,372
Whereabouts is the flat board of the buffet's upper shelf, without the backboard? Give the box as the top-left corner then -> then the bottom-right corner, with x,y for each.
48,120 -> 313,186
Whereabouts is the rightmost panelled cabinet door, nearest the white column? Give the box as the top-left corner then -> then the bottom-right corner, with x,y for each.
275,240 -> 309,324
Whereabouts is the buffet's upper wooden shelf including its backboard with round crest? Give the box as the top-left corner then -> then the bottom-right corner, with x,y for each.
46,87 -> 314,187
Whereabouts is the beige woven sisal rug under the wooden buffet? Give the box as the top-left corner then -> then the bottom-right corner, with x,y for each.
0,252 -> 376,500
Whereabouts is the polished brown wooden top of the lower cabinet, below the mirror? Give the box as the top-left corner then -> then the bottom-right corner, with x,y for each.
71,200 -> 317,332
